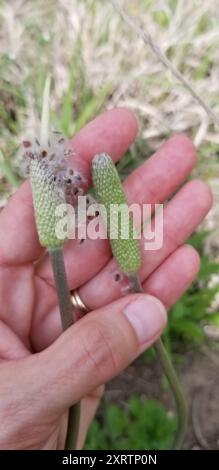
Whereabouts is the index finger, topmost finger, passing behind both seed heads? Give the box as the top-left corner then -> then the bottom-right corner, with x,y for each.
0,108 -> 137,264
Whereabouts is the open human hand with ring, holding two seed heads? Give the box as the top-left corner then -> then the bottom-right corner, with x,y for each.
0,109 -> 211,449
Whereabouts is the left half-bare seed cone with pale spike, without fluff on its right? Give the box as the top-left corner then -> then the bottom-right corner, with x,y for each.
25,77 -> 65,249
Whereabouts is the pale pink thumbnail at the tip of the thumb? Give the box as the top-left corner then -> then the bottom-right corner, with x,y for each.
124,295 -> 167,344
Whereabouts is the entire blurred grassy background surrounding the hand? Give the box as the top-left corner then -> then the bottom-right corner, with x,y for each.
0,0 -> 219,449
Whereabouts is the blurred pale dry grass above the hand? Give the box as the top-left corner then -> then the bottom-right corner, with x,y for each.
0,0 -> 219,196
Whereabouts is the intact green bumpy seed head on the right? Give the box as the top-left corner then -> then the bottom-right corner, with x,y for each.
92,153 -> 141,275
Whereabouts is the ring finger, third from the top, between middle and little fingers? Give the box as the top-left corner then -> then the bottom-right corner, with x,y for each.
74,180 -> 212,310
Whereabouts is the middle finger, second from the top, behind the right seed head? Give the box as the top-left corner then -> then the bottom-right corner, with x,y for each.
38,135 -> 196,289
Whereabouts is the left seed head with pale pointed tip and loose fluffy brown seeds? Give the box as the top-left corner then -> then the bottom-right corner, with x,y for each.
23,78 -> 86,249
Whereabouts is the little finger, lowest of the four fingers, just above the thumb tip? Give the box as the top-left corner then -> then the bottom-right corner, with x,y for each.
32,245 -> 199,351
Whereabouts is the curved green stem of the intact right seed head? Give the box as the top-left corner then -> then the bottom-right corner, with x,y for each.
128,274 -> 188,450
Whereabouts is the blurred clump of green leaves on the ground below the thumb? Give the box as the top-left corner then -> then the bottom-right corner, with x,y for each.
85,396 -> 176,450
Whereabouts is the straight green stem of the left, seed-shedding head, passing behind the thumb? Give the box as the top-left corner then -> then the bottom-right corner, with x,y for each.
49,247 -> 80,450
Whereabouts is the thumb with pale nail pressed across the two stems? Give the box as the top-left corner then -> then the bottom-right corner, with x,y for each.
37,294 -> 166,411
